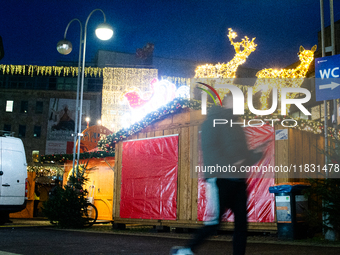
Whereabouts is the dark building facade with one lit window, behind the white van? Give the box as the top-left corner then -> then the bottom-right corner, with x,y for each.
0,65 -> 102,163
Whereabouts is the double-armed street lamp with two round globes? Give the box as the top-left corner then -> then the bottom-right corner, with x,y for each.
57,9 -> 113,176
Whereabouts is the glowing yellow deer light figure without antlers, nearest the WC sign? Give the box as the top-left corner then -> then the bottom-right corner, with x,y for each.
253,45 -> 316,110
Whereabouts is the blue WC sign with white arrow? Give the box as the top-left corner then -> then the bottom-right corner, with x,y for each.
315,55 -> 340,101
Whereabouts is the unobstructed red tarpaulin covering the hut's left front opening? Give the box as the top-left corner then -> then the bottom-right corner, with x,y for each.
120,135 -> 178,220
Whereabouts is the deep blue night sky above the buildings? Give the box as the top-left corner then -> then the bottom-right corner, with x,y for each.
0,0 -> 340,69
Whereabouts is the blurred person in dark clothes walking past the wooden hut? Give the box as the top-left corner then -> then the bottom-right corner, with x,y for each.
170,95 -> 267,255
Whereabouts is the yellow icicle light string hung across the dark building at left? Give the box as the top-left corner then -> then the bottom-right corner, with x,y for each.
0,65 -> 103,77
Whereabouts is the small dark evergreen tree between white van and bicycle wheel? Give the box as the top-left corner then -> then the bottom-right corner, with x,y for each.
43,176 -> 88,228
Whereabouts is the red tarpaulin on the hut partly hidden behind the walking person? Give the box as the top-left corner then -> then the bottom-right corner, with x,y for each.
197,125 -> 275,222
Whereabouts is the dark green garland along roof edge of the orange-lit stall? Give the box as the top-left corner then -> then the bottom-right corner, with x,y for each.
40,151 -> 115,163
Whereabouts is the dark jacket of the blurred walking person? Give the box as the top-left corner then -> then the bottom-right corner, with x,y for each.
201,106 -> 262,180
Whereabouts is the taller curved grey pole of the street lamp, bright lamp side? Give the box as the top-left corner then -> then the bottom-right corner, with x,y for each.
77,9 -> 106,177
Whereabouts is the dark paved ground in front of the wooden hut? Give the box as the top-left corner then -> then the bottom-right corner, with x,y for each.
0,219 -> 340,255
